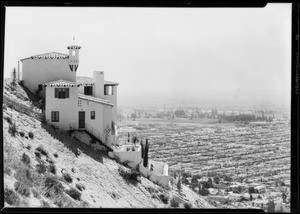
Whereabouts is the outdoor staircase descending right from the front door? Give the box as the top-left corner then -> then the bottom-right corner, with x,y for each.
70,123 -> 113,151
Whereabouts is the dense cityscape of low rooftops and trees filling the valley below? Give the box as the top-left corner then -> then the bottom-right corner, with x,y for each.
119,104 -> 290,212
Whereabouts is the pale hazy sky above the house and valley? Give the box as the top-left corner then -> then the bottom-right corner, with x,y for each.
4,3 -> 291,108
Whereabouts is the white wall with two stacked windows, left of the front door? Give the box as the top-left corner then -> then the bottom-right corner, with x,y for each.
45,86 -> 78,130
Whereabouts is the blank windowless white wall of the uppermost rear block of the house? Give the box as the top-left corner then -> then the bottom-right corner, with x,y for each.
22,58 -> 76,92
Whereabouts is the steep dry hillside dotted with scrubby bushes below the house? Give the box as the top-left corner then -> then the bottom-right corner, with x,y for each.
3,80 -> 213,208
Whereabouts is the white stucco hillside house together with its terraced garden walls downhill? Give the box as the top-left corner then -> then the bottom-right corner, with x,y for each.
18,45 -> 170,188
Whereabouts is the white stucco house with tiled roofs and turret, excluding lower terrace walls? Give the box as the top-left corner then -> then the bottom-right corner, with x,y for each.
20,45 -> 118,148
